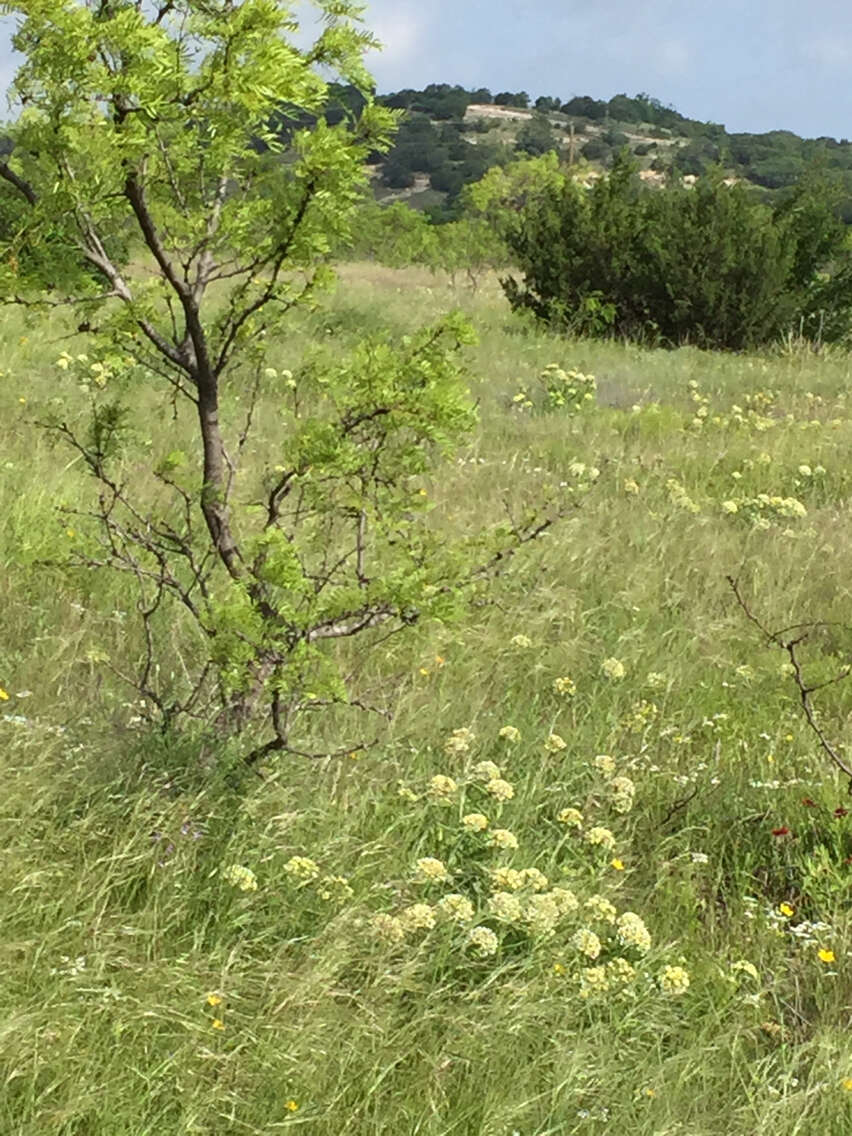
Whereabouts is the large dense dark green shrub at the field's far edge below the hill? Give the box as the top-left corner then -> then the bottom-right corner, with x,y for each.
503,156 -> 852,350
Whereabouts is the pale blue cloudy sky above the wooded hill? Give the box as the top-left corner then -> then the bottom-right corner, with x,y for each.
0,0 -> 852,139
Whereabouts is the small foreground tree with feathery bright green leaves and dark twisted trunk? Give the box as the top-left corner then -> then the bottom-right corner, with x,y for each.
0,0 -> 563,762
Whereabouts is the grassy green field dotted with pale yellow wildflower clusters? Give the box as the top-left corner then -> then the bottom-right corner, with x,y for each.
0,266 -> 852,1136
